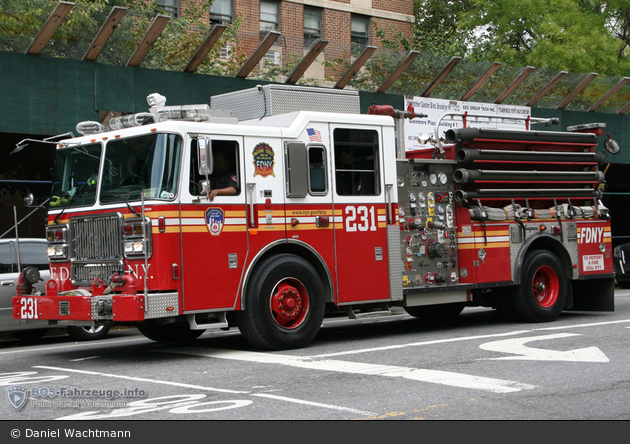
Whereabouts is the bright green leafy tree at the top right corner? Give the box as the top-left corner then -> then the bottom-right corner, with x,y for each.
459,0 -> 630,75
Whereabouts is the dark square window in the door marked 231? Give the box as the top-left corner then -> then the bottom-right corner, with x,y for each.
333,128 -> 380,196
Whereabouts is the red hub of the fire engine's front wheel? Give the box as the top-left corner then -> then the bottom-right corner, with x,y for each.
270,279 -> 308,329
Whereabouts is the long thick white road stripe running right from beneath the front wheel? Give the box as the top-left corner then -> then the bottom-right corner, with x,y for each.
163,347 -> 536,393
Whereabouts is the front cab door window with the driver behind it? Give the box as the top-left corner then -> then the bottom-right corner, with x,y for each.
189,140 -> 241,196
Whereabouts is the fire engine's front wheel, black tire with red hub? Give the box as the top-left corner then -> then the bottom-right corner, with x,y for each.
235,254 -> 325,350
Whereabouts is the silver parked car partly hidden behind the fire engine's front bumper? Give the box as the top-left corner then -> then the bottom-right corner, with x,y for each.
0,238 -> 109,341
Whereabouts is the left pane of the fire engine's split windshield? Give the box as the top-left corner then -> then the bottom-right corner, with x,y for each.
50,143 -> 103,208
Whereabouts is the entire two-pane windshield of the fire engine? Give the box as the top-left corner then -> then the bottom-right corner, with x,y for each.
50,134 -> 182,208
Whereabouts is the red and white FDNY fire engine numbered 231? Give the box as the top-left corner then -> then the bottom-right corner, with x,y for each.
13,85 -> 619,349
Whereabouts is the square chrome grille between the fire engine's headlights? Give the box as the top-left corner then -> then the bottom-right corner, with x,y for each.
70,214 -> 124,261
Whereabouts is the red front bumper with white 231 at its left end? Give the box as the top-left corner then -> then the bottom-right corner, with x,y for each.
13,293 -> 179,322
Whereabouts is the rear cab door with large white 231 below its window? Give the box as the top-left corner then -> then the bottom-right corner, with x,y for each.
330,124 -> 395,304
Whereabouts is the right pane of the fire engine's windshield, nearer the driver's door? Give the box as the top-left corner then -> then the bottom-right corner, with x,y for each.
100,134 -> 182,204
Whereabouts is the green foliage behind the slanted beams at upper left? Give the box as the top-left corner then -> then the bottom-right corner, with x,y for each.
0,0 -> 247,76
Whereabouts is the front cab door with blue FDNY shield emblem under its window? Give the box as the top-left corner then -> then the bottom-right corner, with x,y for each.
180,135 -> 247,312
